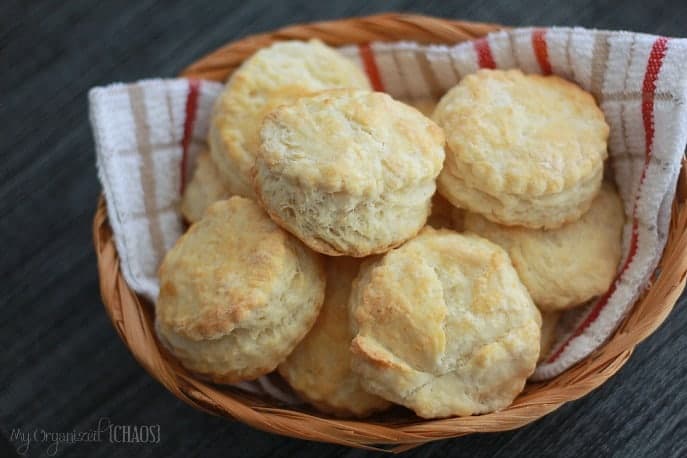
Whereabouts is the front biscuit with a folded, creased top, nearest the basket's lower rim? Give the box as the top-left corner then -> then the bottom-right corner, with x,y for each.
349,227 -> 541,418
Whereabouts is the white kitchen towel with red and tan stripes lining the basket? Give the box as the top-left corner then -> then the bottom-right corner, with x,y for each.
89,27 -> 687,386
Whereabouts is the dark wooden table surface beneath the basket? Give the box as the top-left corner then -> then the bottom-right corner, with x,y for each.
0,0 -> 687,457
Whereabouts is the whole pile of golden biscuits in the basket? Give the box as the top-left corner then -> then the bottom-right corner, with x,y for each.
156,41 -> 625,418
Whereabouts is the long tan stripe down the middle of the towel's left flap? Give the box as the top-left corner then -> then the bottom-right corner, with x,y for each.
129,84 -> 165,259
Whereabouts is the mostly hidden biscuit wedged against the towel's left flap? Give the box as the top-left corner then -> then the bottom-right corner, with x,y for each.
181,150 -> 229,223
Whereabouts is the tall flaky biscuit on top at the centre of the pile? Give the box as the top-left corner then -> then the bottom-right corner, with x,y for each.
253,90 -> 444,257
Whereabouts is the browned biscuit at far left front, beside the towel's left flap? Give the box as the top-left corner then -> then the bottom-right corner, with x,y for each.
155,197 -> 325,383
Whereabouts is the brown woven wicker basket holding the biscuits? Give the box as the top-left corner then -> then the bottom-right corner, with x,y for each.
93,14 -> 687,451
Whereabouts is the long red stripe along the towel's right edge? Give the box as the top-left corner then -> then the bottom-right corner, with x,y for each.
546,37 -> 668,364
